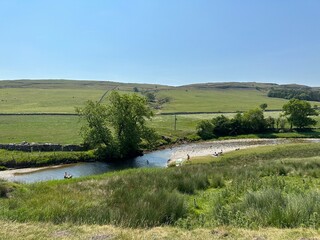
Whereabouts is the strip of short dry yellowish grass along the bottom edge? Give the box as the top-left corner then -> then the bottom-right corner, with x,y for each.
0,221 -> 320,240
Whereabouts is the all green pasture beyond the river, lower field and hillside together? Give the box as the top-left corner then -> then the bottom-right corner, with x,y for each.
0,80 -> 320,144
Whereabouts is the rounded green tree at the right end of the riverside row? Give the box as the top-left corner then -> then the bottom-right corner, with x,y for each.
282,99 -> 318,129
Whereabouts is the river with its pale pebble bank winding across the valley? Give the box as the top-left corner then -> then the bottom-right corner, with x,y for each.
0,139 -> 320,183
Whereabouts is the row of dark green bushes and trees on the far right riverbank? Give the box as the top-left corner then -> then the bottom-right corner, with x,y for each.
197,99 -> 318,140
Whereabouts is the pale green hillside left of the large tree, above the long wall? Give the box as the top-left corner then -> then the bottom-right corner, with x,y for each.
0,80 -> 168,113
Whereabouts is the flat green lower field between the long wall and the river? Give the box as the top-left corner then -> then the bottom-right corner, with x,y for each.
0,112 -> 320,144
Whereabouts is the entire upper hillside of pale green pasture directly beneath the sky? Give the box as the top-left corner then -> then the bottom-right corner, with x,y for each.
0,80 -> 316,113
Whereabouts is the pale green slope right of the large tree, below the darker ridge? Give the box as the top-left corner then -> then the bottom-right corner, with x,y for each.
158,88 -> 287,112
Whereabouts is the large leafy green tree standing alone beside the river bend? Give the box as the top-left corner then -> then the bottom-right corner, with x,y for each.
77,92 -> 156,158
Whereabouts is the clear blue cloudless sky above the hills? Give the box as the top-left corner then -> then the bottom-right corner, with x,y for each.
0,0 -> 320,86
